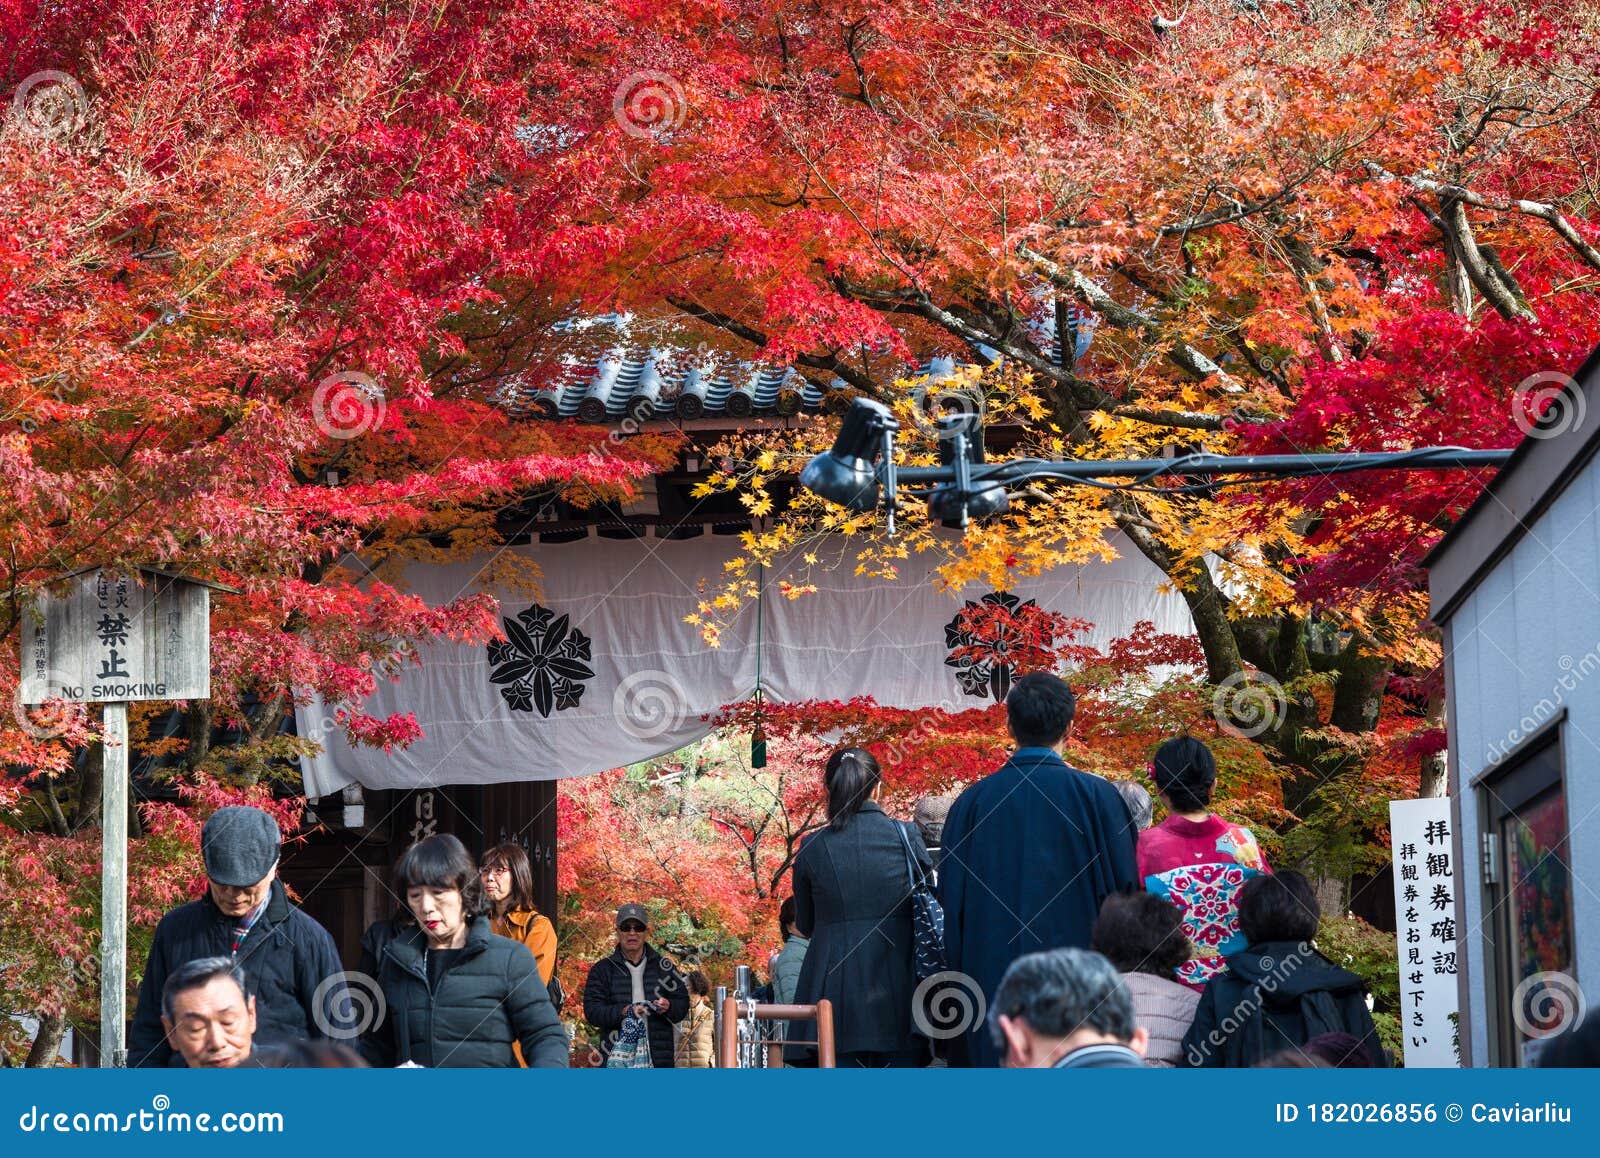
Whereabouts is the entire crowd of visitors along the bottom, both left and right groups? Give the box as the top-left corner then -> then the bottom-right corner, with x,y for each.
130,673 -> 1597,1068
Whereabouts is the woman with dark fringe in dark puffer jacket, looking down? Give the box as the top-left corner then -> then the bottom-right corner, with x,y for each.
361,835 -> 568,1068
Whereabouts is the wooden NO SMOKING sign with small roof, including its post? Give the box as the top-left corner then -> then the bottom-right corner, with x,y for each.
19,568 -> 232,1068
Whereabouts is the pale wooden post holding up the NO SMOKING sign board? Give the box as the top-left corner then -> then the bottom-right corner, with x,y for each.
101,702 -> 128,1070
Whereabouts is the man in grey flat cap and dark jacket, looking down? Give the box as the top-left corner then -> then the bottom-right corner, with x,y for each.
128,806 -> 347,1067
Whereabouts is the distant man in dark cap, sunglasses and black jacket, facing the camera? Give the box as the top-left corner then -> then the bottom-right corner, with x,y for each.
584,904 -> 690,1070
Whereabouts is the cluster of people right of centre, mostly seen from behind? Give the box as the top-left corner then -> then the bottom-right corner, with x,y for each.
764,673 -> 1389,1068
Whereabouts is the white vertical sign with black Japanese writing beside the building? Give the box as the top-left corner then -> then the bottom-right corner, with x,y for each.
1389,797 -> 1461,1068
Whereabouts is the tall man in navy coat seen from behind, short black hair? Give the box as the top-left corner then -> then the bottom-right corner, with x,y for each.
939,672 -> 1138,1067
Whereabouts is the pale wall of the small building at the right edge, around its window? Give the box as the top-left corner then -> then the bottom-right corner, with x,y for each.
1446,465 -> 1600,1065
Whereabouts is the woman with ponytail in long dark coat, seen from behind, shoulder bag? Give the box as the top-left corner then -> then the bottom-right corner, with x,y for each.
784,749 -> 933,1067
